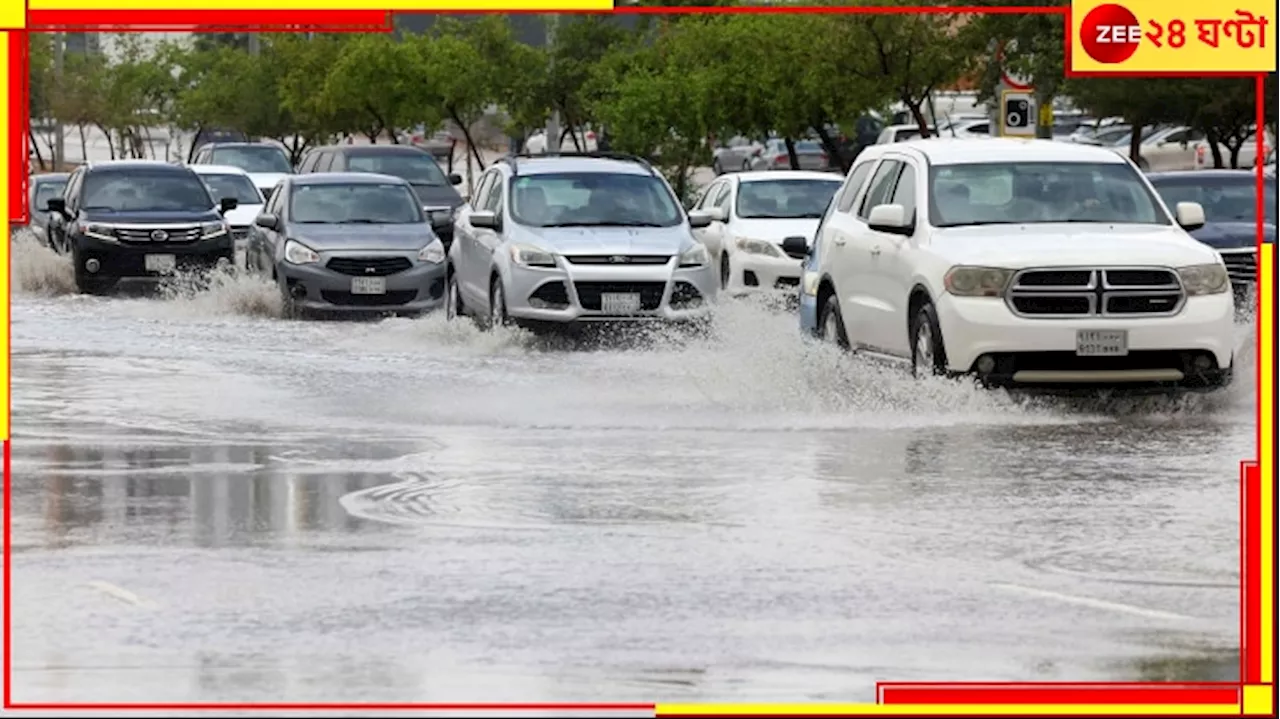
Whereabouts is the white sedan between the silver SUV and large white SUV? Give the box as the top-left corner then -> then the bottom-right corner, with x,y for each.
690,170 -> 844,290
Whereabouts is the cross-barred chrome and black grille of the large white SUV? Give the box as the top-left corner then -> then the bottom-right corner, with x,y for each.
1006,267 -> 1185,317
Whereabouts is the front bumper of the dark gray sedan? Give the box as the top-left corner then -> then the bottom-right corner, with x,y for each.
275,251 -> 445,313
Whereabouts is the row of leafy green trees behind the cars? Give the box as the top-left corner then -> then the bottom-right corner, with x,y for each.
31,0 -> 1275,189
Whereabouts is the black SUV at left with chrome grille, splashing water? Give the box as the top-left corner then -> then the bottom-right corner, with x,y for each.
45,160 -> 236,293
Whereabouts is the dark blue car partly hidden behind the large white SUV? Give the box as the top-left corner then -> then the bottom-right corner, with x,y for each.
1147,170 -> 1276,304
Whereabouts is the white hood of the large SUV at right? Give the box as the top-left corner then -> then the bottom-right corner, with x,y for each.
931,223 -> 1219,269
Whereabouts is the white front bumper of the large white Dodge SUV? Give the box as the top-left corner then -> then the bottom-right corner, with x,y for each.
937,293 -> 1235,388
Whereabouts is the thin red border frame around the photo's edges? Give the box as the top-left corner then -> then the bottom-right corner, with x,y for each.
3,6 -> 1266,711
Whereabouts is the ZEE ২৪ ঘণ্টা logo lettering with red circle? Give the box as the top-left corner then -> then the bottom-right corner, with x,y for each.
1080,4 -> 1275,65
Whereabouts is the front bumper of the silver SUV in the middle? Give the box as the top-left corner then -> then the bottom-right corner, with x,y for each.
503,257 -> 718,324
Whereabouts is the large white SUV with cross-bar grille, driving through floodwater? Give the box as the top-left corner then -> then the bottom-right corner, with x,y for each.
800,138 -> 1235,389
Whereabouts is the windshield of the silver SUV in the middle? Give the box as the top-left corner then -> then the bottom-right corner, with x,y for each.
511,173 -> 685,228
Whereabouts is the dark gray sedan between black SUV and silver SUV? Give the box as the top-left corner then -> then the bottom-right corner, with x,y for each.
246,173 -> 445,313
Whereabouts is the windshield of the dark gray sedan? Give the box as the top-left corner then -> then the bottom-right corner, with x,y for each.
289,183 -> 424,225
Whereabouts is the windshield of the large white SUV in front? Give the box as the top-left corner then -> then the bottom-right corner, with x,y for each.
929,162 -> 1170,228
